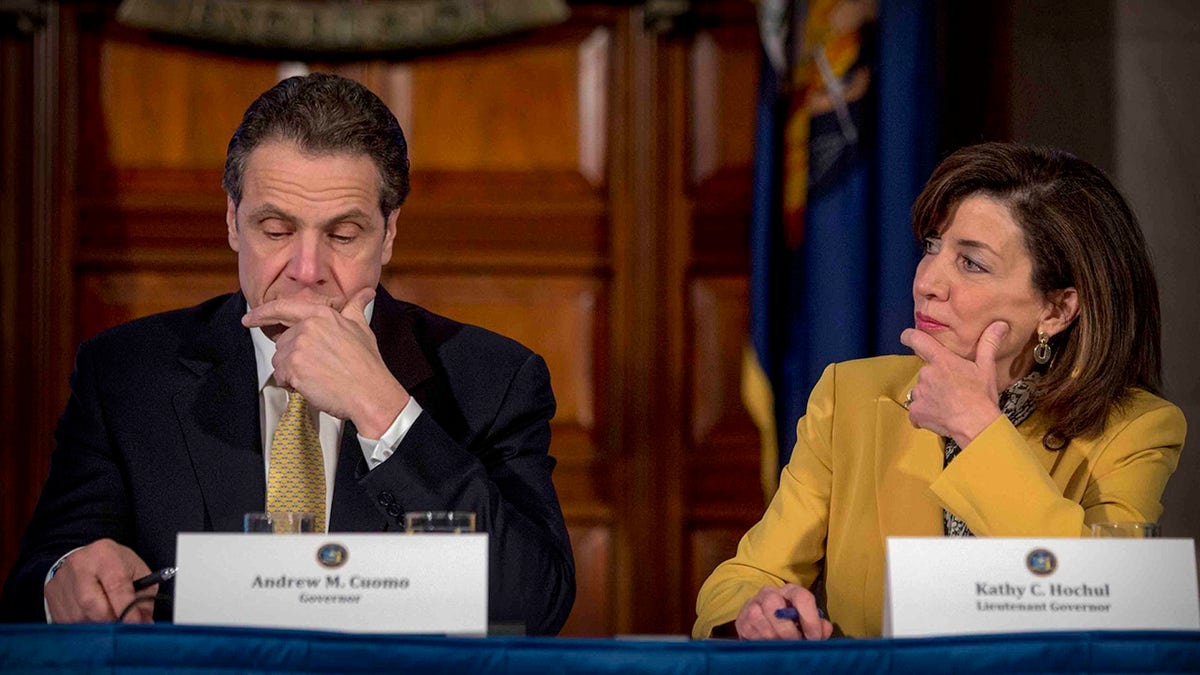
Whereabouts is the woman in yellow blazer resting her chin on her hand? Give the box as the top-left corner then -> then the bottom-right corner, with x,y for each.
692,143 -> 1186,639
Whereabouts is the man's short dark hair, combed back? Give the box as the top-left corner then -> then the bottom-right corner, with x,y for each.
221,73 -> 408,219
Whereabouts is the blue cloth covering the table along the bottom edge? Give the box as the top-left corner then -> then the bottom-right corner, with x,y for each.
0,625 -> 1200,675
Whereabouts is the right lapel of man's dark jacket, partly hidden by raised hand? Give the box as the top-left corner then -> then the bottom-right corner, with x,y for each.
329,286 -> 433,532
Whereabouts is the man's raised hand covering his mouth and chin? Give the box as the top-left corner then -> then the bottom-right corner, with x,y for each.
241,288 -> 409,438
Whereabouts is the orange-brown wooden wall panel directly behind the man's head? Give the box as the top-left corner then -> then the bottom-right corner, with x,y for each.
80,26 -> 608,270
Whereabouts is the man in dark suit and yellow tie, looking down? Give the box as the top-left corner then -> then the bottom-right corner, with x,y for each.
0,74 -> 575,634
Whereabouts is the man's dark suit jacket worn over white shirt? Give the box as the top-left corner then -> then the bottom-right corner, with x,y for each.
0,287 -> 575,634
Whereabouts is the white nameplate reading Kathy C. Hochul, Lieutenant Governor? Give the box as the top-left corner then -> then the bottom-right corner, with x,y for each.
883,537 -> 1200,638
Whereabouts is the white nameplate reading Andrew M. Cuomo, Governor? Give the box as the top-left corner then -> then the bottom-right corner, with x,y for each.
175,533 -> 487,635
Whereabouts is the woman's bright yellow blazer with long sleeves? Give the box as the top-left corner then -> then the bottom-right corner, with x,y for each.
692,357 -> 1187,638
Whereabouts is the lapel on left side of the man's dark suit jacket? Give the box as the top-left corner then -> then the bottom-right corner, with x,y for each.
173,293 -> 266,532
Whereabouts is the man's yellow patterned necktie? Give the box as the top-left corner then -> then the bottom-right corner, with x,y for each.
266,392 -> 325,532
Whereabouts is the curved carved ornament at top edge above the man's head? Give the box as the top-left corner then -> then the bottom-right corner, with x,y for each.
116,0 -> 570,53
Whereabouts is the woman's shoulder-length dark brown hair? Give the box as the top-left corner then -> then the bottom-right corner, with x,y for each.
912,143 -> 1163,449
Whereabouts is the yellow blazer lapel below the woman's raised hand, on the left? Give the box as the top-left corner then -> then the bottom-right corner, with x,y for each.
875,376 -> 943,537
